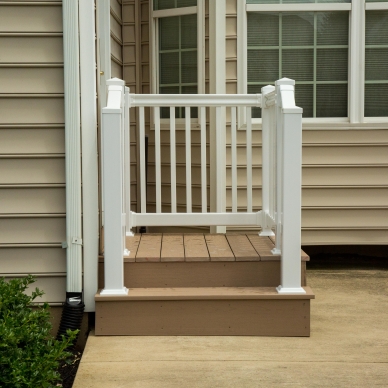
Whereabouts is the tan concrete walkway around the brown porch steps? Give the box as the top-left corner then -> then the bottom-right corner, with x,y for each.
73,269 -> 388,388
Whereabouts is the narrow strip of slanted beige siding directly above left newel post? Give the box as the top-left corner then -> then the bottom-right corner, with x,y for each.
110,0 -> 123,79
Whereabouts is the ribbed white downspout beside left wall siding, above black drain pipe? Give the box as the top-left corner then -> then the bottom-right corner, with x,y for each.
62,0 -> 82,292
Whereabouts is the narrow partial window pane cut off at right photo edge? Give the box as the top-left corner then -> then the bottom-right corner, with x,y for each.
364,10 -> 388,117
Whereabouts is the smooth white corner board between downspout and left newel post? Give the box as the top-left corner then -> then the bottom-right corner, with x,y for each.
79,0 -> 99,311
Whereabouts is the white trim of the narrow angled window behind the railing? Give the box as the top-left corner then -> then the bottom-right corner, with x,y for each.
149,0 -> 205,130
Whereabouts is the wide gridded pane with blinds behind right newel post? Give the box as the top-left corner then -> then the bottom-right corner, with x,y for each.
248,12 -> 349,117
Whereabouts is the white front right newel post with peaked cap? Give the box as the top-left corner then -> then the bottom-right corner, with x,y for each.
276,78 -> 306,294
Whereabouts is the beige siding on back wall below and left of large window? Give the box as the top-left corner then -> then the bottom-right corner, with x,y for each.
226,0 -> 388,245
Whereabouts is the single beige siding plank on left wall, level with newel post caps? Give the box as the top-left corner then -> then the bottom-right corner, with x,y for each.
0,68 -> 63,93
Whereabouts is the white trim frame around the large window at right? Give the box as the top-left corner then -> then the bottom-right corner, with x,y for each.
237,0 -> 388,130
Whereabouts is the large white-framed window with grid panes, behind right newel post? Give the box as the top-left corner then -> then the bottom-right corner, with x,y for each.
238,0 -> 388,123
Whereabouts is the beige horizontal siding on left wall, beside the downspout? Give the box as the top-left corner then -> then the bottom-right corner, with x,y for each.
0,1 -> 66,303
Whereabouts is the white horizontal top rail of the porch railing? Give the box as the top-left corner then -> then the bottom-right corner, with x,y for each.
130,94 -> 261,107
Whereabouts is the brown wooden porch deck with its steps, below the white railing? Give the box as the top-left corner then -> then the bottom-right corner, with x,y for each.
95,233 -> 314,336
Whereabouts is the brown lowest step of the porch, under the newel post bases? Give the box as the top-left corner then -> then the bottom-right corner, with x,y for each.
96,287 -> 314,336
